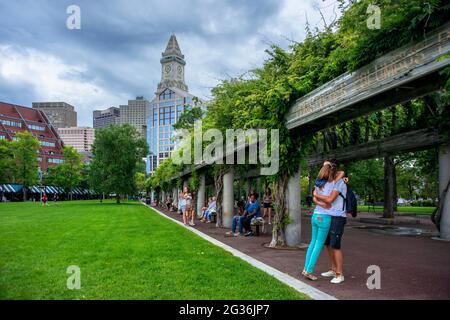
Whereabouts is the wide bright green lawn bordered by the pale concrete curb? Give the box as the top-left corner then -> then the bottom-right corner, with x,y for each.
0,202 -> 307,300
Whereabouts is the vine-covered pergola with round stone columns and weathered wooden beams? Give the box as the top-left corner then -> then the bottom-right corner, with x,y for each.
154,23 -> 450,242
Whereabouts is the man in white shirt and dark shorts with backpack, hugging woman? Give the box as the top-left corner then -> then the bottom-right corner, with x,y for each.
314,160 -> 357,284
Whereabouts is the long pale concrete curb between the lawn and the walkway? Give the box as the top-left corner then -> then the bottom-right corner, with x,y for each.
143,203 -> 337,300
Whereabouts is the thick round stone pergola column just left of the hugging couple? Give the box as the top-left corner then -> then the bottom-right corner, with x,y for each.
286,170 -> 302,247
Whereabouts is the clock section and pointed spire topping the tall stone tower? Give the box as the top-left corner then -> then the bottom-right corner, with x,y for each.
158,33 -> 188,93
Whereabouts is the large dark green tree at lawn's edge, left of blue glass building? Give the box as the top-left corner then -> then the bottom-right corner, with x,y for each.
89,124 -> 148,203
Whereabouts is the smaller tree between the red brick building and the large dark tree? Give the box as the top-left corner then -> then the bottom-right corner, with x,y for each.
47,146 -> 83,200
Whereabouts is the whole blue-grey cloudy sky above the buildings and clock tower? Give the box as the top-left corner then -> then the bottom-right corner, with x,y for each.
0,0 -> 338,126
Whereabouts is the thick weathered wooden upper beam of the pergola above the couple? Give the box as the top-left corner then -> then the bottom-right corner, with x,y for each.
286,23 -> 450,134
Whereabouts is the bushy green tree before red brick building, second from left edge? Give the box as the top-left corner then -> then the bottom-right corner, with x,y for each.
12,131 -> 40,201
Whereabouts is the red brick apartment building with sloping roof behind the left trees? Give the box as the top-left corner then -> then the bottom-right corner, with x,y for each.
0,102 -> 64,172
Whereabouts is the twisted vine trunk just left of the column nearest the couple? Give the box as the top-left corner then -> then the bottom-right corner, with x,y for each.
269,174 -> 289,248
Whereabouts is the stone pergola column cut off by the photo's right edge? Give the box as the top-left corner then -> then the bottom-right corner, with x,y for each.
439,145 -> 450,240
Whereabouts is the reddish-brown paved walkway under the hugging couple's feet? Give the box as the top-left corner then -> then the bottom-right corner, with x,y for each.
152,206 -> 450,299
